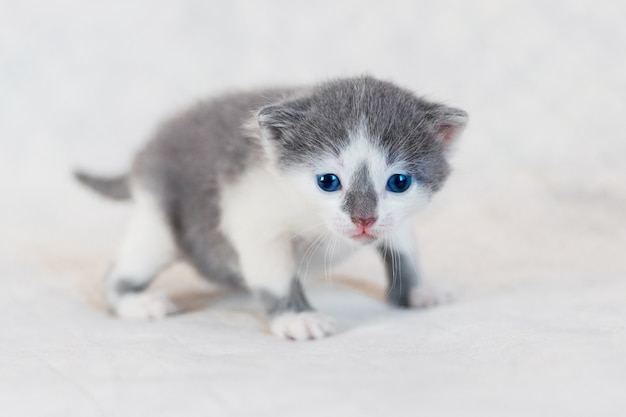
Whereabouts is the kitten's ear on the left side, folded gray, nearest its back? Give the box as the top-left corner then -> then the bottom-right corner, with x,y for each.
257,98 -> 311,141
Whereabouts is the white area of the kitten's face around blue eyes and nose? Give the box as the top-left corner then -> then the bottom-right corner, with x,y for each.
291,122 -> 432,244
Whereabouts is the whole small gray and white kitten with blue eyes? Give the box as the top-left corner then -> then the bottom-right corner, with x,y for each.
77,77 -> 467,340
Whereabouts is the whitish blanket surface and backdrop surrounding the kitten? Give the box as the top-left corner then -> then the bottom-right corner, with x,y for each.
0,0 -> 626,417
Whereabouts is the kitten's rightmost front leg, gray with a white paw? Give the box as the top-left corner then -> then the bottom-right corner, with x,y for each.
378,228 -> 449,308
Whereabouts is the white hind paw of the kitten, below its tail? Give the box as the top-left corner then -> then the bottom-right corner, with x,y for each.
115,293 -> 178,320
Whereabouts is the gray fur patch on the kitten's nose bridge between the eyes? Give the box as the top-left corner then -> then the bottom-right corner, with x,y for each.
342,163 -> 378,219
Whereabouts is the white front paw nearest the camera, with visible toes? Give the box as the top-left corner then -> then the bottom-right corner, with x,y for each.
270,311 -> 335,340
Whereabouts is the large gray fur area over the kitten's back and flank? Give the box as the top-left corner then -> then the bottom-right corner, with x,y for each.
131,89 -> 295,284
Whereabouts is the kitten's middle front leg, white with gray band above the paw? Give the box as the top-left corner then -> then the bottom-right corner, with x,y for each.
238,236 -> 334,340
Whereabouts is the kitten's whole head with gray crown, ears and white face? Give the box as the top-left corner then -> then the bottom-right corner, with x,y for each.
258,77 -> 467,243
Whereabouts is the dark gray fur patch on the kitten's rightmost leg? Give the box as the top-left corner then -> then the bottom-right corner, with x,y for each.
378,245 -> 420,307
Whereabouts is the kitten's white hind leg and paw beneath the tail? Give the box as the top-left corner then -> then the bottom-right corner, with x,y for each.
105,188 -> 176,319
